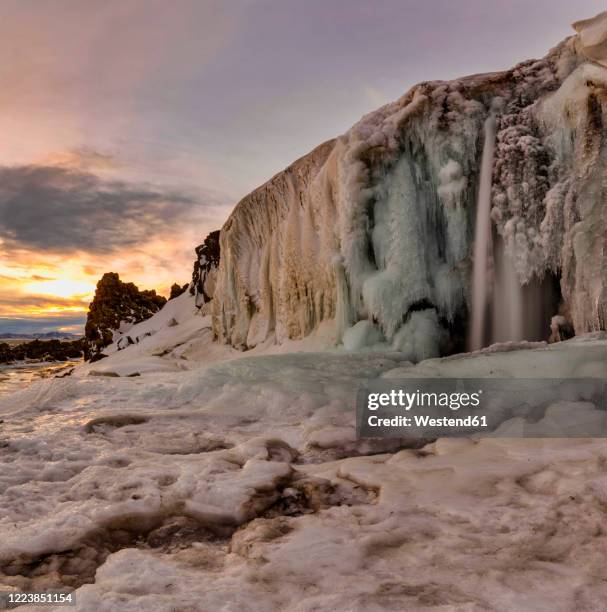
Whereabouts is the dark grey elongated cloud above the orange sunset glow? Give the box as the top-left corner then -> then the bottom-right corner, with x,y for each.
0,161 -> 214,254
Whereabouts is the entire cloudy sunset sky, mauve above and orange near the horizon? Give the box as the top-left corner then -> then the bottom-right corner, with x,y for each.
0,0 -> 604,334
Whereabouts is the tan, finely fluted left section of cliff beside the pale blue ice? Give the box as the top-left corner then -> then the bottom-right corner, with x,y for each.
213,141 -> 337,347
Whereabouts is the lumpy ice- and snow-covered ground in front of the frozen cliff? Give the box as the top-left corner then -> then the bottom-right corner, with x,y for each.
0,299 -> 607,612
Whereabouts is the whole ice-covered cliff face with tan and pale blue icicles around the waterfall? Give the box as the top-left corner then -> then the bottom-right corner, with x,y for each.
213,14 -> 607,358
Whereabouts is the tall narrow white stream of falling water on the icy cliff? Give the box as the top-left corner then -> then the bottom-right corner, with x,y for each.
469,113 -> 495,351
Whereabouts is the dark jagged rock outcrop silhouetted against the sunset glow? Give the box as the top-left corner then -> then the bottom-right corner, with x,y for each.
84,272 -> 167,361
